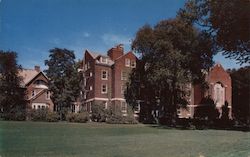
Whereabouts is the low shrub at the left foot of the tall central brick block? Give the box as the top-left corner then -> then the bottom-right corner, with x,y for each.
66,112 -> 89,123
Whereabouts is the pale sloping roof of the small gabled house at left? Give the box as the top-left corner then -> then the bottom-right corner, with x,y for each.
19,69 -> 40,86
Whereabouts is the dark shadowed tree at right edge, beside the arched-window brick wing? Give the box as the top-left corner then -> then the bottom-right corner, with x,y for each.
229,66 -> 250,123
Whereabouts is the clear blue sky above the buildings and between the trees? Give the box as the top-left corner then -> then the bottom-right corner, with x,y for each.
0,0 -> 246,69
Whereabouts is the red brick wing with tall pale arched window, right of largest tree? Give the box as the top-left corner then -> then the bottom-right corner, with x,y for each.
178,64 -> 232,118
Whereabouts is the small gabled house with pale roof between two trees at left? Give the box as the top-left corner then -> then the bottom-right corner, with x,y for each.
19,66 -> 54,111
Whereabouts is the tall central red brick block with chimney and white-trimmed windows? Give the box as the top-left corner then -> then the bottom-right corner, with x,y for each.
83,45 -> 137,114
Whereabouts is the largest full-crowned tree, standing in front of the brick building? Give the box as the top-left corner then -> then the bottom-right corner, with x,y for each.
125,18 -> 214,124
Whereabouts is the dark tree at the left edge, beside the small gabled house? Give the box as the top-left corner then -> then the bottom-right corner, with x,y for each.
0,50 -> 26,120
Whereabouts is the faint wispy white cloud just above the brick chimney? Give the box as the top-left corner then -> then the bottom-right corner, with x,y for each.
101,33 -> 132,46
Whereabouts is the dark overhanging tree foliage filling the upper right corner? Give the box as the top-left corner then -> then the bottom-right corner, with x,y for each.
178,0 -> 250,64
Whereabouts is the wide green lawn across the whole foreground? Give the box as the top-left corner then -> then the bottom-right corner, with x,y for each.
0,121 -> 250,157
